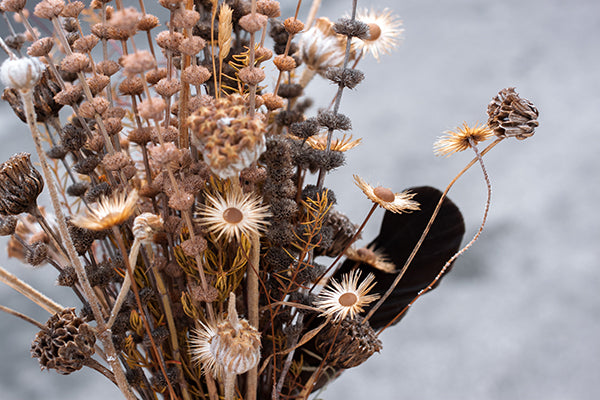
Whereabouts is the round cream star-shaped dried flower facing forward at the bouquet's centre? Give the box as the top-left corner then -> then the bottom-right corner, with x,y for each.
196,189 -> 271,241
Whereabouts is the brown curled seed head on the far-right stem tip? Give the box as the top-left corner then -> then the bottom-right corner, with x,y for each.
487,87 -> 539,140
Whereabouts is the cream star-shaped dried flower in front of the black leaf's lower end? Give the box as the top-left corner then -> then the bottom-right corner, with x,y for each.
315,270 -> 379,322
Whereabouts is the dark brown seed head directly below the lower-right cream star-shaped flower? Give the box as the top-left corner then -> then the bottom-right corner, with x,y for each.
316,316 -> 382,368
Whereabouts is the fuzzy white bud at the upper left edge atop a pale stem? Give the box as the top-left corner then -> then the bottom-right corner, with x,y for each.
0,57 -> 46,91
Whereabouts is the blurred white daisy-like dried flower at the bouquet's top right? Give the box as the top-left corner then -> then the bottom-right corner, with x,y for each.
352,9 -> 404,61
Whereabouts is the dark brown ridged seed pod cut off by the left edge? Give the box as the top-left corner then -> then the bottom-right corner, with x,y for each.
0,153 -> 44,215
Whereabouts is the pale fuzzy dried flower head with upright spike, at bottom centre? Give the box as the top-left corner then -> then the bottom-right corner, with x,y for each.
189,292 -> 260,377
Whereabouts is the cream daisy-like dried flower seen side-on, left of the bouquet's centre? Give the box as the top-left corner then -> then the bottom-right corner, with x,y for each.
71,189 -> 139,231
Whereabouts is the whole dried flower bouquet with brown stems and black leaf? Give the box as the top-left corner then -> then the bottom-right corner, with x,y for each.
0,0 -> 538,400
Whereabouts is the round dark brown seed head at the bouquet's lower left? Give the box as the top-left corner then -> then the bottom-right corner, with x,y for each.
31,308 -> 96,375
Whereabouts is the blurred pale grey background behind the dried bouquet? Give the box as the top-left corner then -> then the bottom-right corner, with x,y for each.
0,0 -> 600,400
